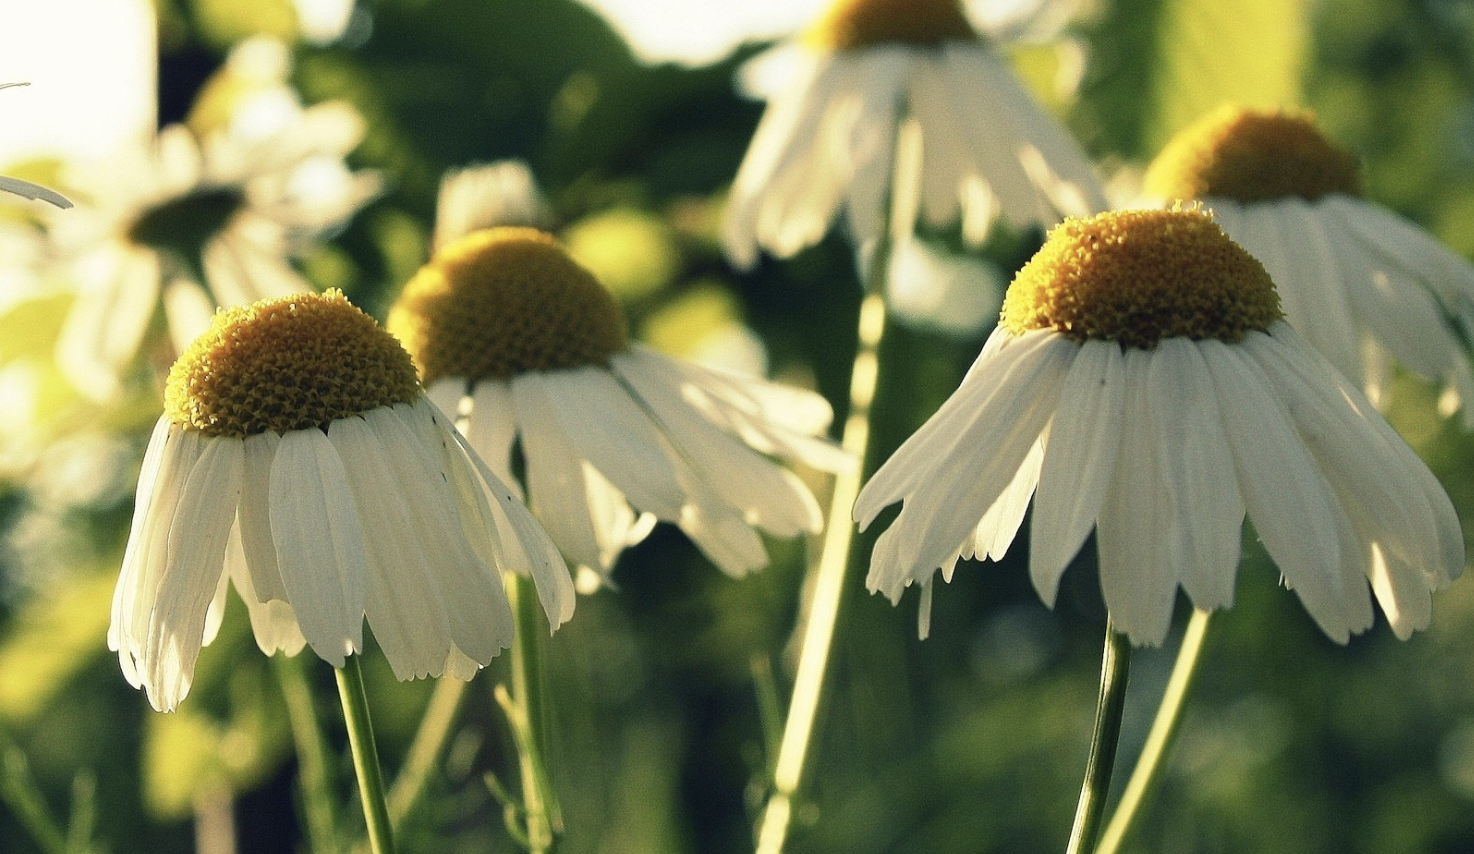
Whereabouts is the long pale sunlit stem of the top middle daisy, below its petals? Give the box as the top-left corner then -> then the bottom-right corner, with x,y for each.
758,235 -> 892,854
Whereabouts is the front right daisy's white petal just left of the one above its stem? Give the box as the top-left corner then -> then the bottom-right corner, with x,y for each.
1029,341 -> 1125,608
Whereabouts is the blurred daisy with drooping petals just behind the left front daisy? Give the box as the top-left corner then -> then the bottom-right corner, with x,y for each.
388,227 -> 853,577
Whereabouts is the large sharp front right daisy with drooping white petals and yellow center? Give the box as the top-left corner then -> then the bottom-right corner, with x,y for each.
855,209 -> 1464,645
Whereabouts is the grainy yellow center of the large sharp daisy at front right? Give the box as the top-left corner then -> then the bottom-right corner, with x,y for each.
999,208 -> 1284,350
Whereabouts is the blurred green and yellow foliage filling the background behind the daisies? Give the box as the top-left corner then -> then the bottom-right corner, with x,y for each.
0,0 -> 1474,854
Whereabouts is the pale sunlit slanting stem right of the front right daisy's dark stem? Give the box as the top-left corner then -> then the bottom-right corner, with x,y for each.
1095,611 -> 1210,854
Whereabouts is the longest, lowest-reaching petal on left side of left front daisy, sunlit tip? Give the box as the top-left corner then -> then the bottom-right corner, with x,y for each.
143,437 -> 245,711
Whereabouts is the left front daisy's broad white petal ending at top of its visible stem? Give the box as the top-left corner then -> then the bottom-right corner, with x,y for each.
268,429 -> 369,667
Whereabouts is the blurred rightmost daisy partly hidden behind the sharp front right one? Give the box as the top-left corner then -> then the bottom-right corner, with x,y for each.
1145,106 -> 1474,429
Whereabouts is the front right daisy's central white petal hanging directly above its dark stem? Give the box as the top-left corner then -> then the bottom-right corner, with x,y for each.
1095,344 -> 1184,646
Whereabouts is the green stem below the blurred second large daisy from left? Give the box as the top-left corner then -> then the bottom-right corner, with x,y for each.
507,574 -> 563,854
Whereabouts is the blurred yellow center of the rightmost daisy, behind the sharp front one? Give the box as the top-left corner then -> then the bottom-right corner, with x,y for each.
1145,106 -> 1361,202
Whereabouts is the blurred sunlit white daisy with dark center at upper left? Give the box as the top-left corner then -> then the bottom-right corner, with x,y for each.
53,103 -> 379,400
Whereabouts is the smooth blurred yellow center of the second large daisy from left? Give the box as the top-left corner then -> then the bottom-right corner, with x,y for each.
388,229 -> 628,385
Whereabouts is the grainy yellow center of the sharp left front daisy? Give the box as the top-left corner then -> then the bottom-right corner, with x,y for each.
164,291 -> 420,438
